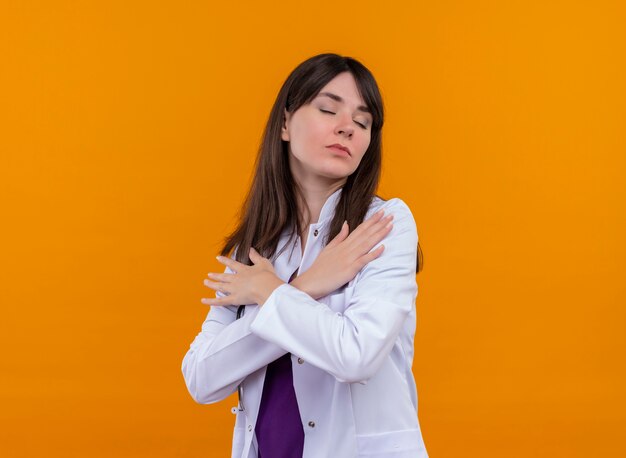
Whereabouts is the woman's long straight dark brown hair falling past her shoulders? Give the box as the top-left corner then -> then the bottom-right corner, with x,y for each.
221,53 -> 422,272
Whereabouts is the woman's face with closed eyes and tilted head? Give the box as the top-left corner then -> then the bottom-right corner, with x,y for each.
281,72 -> 372,183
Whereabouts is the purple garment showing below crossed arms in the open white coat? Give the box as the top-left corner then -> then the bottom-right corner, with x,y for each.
255,353 -> 304,458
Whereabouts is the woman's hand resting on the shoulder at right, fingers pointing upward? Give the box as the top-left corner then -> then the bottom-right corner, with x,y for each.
290,210 -> 393,299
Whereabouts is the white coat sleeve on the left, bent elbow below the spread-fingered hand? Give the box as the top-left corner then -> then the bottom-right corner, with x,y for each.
182,260 -> 285,404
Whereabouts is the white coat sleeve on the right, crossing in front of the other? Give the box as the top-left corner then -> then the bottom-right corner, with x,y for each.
250,199 -> 418,383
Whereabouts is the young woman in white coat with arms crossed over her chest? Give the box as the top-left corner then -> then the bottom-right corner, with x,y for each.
182,54 -> 427,458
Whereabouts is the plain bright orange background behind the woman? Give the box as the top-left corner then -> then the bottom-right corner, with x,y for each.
0,1 -> 626,458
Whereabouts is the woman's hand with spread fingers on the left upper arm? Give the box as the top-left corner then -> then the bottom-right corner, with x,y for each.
201,248 -> 284,305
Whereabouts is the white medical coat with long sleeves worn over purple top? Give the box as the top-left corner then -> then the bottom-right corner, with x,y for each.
182,189 -> 428,458
